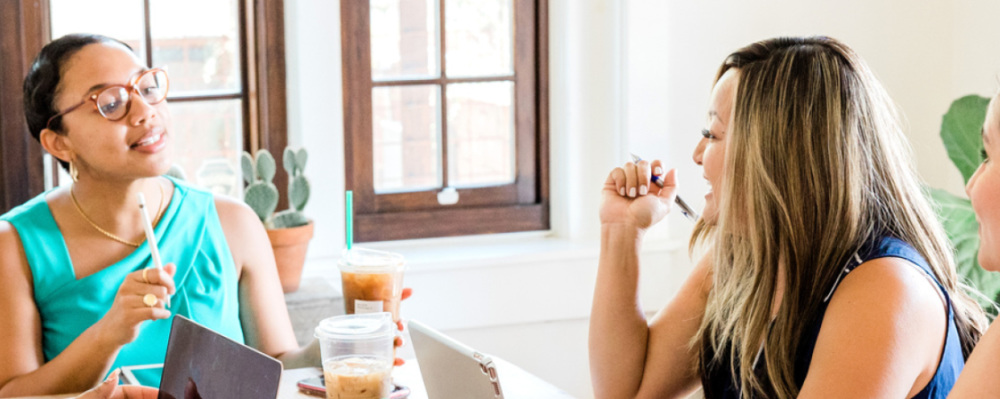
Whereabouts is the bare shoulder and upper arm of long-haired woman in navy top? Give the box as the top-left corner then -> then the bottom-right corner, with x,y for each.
803,257 -> 948,394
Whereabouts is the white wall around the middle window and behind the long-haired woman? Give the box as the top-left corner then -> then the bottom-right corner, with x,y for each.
285,0 -> 1000,397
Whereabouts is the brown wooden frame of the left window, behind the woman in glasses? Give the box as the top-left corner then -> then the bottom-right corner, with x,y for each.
0,0 -> 288,213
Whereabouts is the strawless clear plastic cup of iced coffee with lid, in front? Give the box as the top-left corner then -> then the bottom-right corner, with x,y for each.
316,312 -> 396,399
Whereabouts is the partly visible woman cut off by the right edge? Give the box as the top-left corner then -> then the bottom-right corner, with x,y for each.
951,94 -> 1000,398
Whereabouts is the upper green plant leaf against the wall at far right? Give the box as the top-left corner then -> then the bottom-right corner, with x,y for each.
941,95 -> 990,183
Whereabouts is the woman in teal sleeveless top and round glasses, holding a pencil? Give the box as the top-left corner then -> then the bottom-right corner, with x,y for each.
0,35 -> 319,397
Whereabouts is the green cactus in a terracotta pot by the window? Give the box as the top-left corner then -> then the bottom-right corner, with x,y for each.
241,148 -> 313,293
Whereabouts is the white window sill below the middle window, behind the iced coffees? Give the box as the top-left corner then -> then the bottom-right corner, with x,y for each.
303,232 -> 691,330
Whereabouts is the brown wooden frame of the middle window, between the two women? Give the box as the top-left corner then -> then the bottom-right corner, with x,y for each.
341,0 -> 549,242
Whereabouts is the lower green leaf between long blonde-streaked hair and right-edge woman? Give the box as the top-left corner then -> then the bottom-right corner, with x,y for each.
930,189 -> 1000,313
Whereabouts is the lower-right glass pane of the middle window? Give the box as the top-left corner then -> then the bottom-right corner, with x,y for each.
447,82 -> 516,187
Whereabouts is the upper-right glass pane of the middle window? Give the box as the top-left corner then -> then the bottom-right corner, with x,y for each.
444,0 -> 514,77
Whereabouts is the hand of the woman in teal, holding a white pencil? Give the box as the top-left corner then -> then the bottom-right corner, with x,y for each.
95,263 -> 177,346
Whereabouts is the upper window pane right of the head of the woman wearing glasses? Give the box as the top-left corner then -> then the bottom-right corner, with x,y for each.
149,0 -> 240,97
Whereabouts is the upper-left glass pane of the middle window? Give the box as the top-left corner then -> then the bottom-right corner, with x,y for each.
370,0 -> 440,80
